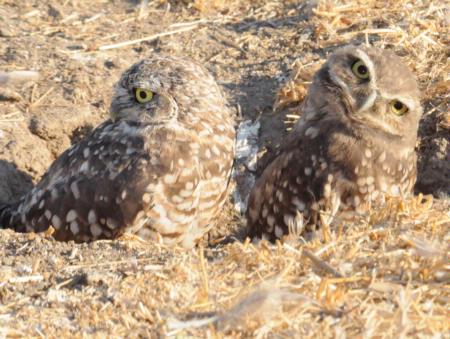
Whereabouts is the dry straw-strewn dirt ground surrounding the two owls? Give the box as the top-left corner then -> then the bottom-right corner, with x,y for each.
0,0 -> 450,338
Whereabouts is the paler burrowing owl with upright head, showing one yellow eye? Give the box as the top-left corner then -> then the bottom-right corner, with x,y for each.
0,57 -> 235,248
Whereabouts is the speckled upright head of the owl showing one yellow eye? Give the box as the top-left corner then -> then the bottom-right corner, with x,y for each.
110,56 -> 218,123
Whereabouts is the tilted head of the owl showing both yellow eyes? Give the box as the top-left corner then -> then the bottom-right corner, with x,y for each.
305,46 -> 422,146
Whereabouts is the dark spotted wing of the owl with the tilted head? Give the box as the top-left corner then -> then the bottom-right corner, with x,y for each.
247,129 -> 352,241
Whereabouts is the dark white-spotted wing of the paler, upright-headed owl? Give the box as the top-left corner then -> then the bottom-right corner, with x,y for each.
17,121 -> 202,241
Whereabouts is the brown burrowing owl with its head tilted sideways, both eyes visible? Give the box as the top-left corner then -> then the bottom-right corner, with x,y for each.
247,46 -> 422,240
